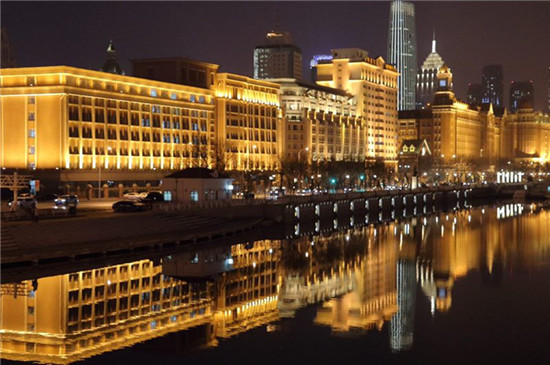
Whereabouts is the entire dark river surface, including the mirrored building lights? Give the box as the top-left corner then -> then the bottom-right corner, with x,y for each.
0,204 -> 550,364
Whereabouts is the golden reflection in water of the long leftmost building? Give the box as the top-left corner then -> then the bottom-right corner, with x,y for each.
0,260 -> 213,363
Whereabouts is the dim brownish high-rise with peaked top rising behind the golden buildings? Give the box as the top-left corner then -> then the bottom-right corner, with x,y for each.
254,30 -> 302,80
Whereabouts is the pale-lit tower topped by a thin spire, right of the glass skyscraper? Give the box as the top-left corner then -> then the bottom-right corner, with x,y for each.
416,34 -> 444,108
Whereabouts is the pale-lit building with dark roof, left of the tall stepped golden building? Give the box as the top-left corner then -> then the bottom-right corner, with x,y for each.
270,79 -> 367,162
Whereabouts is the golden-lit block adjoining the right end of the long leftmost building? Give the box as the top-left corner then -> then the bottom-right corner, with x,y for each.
214,73 -> 283,171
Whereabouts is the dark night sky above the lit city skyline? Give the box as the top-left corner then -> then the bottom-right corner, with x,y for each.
0,1 -> 550,110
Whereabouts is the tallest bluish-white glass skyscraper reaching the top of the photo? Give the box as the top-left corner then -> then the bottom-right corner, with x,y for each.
388,0 -> 417,110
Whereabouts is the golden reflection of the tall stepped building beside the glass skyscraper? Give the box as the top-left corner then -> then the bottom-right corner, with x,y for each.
315,225 -> 397,333
